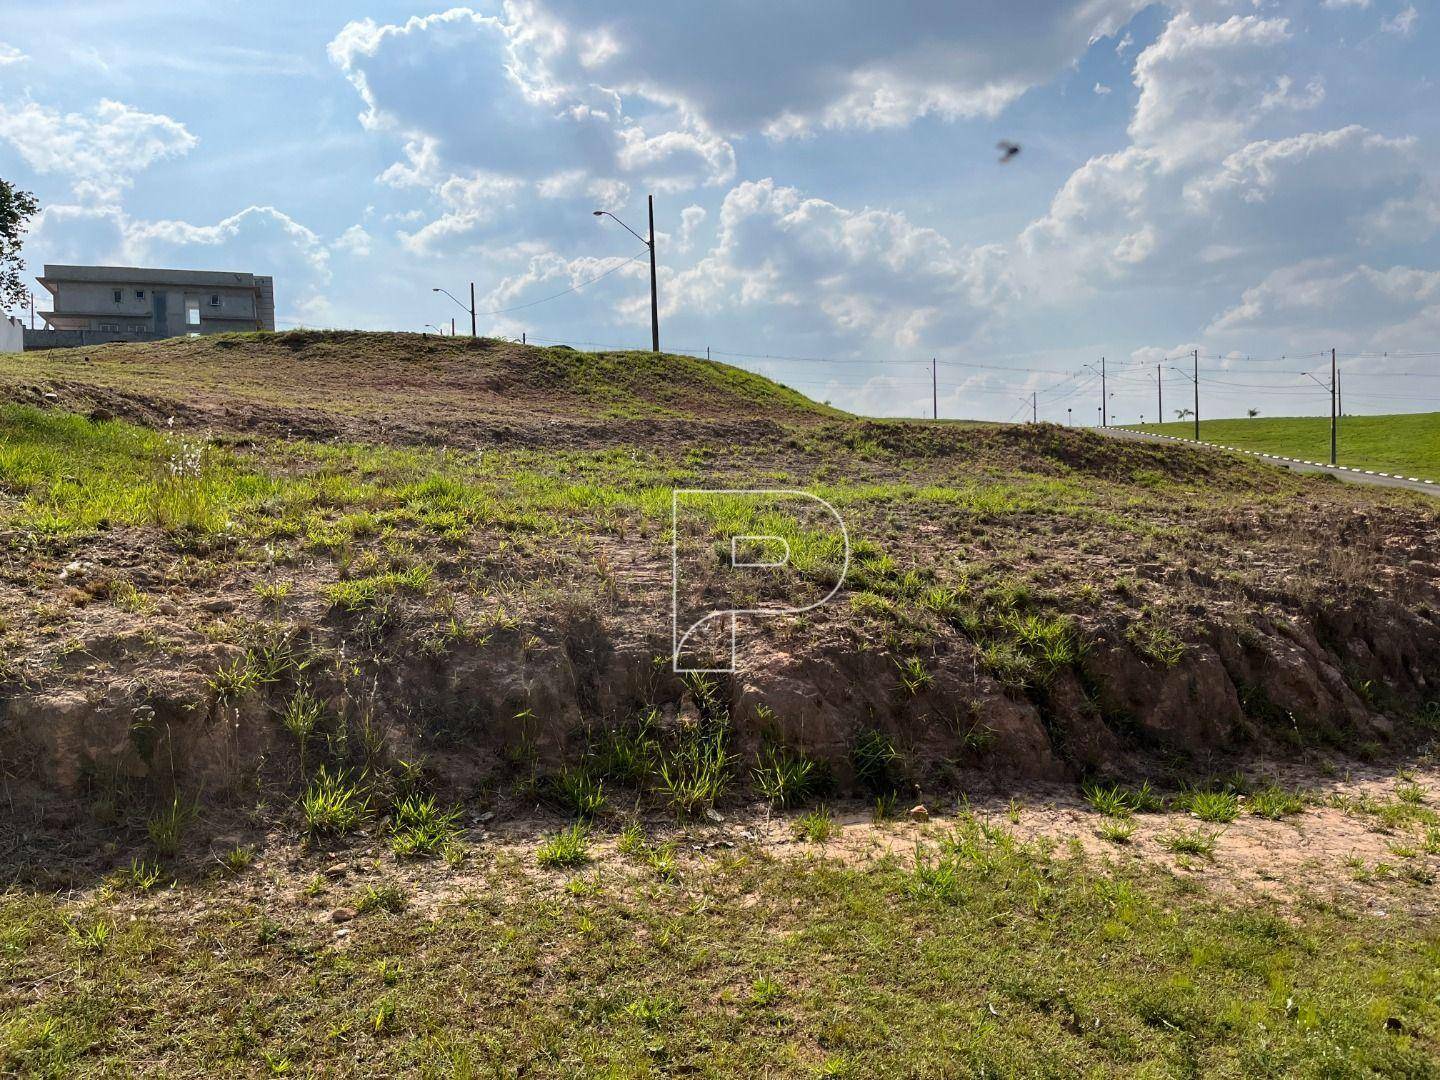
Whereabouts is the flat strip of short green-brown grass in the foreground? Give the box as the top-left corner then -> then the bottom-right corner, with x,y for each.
0,822 -> 1440,1077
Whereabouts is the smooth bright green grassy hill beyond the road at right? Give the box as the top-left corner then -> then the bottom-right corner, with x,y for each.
1135,412 -> 1440,480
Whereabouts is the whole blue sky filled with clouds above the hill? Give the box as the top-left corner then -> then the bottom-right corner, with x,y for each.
0,0 -> 1440,423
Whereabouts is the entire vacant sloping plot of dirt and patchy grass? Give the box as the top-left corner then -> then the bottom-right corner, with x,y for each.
0,333 -> 1440,1077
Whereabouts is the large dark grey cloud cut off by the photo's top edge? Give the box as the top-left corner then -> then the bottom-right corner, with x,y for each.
507,0 -> 1145,138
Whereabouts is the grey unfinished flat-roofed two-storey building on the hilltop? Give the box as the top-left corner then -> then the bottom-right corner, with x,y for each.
24,264 -> 275,348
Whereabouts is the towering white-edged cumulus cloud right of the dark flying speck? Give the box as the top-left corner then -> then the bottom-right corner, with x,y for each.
1018,13 -> 1422,302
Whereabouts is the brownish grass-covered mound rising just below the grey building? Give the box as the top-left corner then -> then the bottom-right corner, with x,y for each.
0,331 -> 841,446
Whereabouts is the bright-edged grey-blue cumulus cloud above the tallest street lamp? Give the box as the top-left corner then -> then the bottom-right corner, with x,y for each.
330,7 -> 734,249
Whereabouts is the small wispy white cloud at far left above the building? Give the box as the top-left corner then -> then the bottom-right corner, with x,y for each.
0,99 -> 199,203
